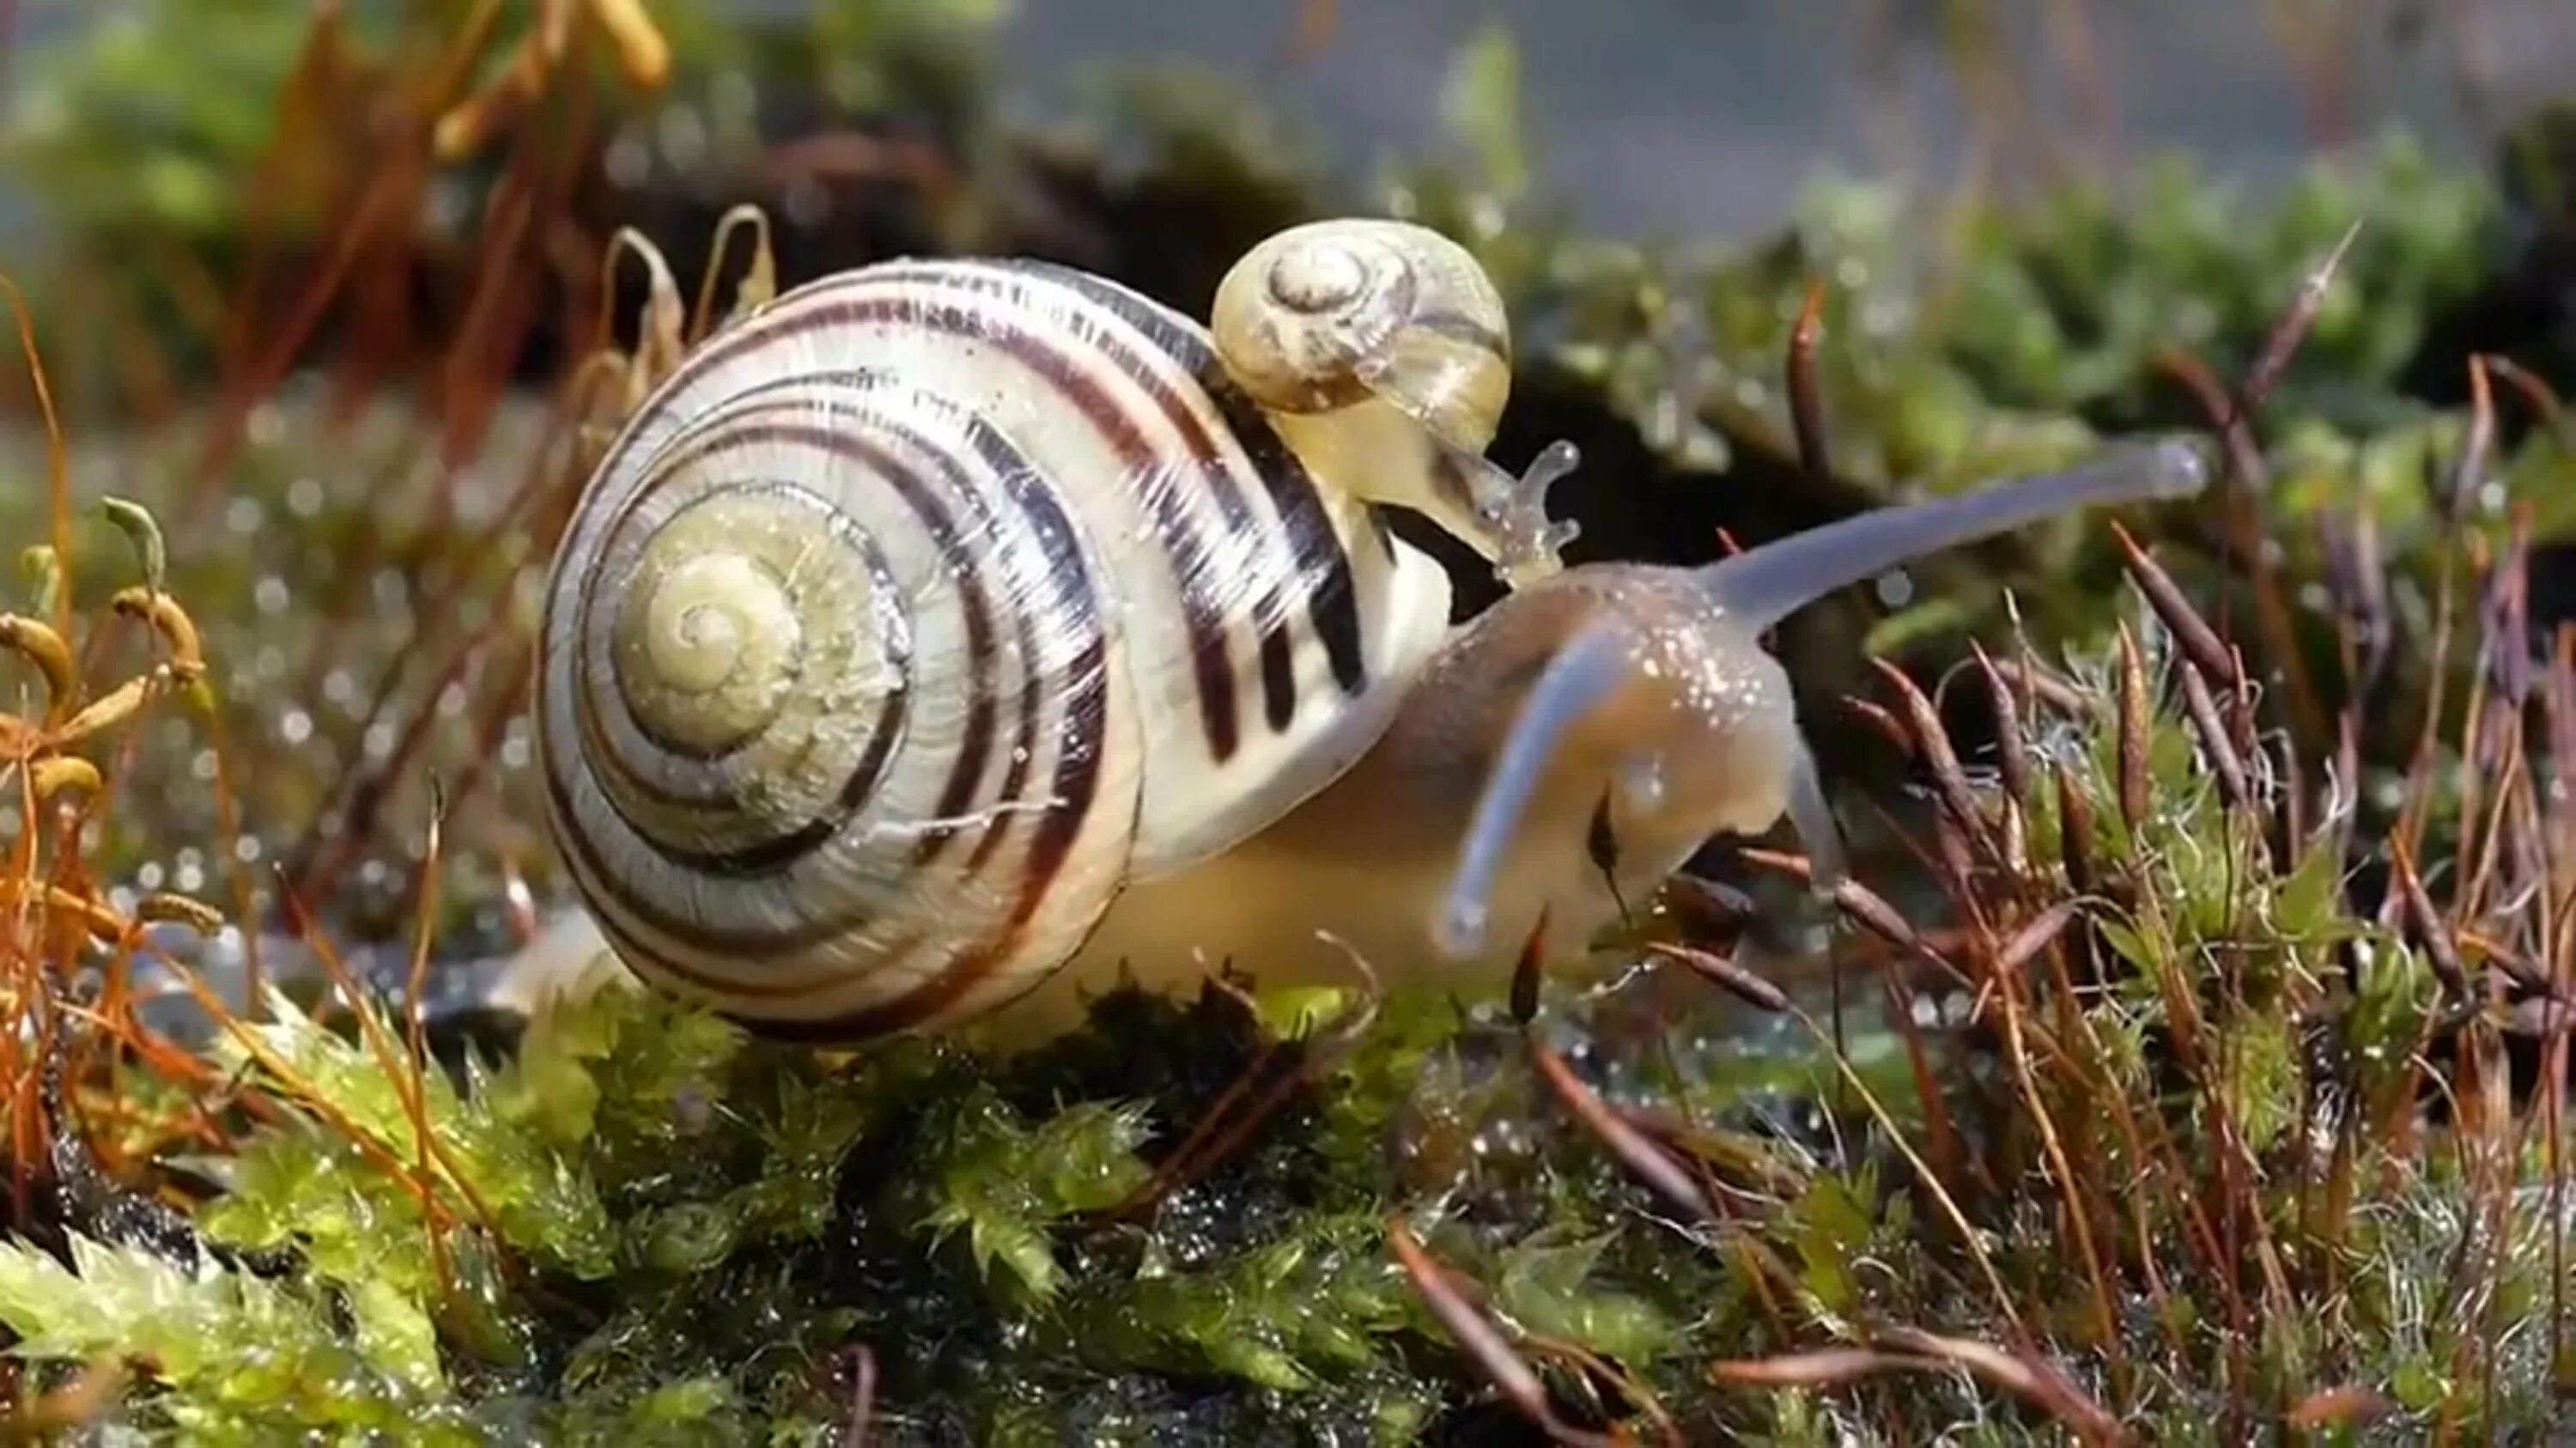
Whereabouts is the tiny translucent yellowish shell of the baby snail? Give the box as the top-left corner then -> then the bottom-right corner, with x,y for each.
1208,219 -> 1512,453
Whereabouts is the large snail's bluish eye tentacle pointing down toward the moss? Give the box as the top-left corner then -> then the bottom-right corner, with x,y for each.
1432,624 -> 1633,958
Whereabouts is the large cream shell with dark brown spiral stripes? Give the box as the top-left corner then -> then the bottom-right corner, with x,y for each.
536,260 -> 1448,1038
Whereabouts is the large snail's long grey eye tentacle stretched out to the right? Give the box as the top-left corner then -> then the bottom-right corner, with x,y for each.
1700,438 -> 2210,631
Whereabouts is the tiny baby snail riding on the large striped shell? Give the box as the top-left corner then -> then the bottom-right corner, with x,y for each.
1211,219 -> 1579,587
